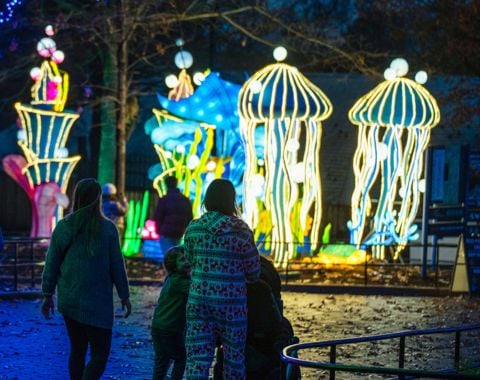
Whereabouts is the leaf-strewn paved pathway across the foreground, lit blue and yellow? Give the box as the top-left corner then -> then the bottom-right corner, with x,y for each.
0,286 -> 480,380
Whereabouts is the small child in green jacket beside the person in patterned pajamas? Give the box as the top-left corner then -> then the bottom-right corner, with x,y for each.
152,246 -> 191,380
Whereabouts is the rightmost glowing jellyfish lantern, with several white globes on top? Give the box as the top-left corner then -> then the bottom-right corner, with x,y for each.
348,58 -> 440,259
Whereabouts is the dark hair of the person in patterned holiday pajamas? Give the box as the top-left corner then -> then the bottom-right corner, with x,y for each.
203,179 -> 238,216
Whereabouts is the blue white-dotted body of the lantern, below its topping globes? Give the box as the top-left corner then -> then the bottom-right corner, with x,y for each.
150,72 -> 245,202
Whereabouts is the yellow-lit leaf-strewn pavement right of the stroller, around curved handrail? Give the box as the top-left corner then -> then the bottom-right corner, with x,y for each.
285,293 -> 480,379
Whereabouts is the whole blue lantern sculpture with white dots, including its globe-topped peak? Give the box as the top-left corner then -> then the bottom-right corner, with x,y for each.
145,39 -> 245,220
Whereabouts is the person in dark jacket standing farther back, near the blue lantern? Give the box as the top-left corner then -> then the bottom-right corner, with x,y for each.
153,176 -> 193,254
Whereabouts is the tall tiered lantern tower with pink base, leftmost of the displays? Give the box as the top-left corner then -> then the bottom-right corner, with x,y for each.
3,29 -> 80,237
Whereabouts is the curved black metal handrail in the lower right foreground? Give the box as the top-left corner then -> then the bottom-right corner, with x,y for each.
282,324 -> 480,380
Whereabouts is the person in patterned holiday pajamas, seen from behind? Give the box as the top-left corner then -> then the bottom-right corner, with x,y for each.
184,179 -> 260,380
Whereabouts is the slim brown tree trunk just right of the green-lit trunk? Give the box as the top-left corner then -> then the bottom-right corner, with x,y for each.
117,0 -> 128,194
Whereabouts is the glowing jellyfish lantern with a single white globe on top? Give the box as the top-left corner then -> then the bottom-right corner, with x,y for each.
239,48 -> 332,265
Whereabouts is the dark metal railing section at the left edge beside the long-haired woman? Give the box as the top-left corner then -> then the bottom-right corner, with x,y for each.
0,237 -> 49,291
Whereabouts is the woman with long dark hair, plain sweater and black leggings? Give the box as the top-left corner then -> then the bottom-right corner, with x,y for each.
41,178 -> 132,380
